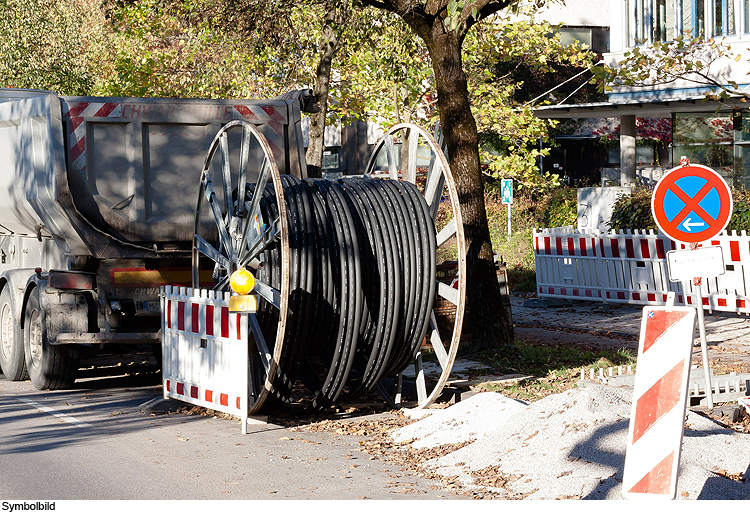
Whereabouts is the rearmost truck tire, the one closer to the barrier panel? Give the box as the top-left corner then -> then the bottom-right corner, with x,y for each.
23,288 -> 80,390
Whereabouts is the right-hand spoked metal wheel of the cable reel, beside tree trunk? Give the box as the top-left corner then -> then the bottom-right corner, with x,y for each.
365,123 -> 466,408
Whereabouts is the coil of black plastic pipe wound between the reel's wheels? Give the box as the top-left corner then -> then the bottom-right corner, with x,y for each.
248,176 -> 436,410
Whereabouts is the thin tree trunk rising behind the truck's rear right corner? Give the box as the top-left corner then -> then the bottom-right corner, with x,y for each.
305,27 -> 338,178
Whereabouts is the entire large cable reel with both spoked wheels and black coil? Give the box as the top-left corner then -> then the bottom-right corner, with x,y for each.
193,121 -> 465,413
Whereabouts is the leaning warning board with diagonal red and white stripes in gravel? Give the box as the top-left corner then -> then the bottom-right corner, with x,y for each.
622,306 -> 696,499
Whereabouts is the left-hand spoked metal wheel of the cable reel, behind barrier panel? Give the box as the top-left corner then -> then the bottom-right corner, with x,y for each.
193,121 -> 289,413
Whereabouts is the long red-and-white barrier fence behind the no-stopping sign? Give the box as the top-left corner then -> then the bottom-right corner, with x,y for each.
534,227 -> 750,313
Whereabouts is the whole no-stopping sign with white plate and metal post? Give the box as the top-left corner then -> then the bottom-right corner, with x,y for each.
651,158 -> 733,409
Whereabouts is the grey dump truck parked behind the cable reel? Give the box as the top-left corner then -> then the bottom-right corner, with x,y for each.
0,89 -> 311,389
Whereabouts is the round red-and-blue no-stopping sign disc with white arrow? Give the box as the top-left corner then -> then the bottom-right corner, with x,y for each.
651,165 -> 733,243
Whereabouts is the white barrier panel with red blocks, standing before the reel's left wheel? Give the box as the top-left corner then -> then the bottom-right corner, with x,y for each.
161,286 -> 253,433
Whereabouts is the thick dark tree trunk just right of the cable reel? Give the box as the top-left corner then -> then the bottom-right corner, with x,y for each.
425,32 -> 513,347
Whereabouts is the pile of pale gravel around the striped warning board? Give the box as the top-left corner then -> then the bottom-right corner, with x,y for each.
393,386 -> 750,500
